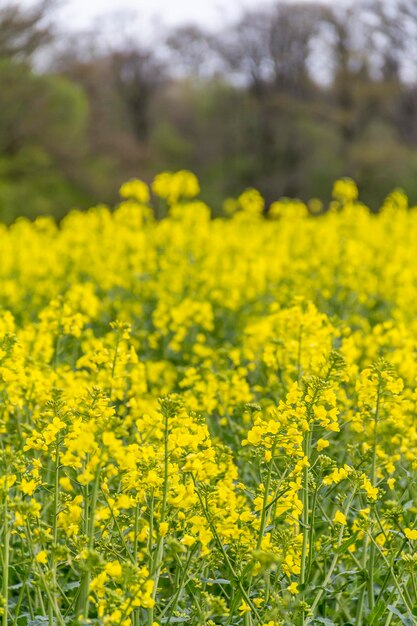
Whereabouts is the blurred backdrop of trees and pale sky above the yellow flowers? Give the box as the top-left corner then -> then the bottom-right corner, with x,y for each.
0,0 -> 417,222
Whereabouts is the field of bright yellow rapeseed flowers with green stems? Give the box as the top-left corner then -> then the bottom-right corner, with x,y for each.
0,172 -> 417,626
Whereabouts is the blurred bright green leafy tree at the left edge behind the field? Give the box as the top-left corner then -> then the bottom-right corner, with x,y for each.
0,59 -> 92,219
